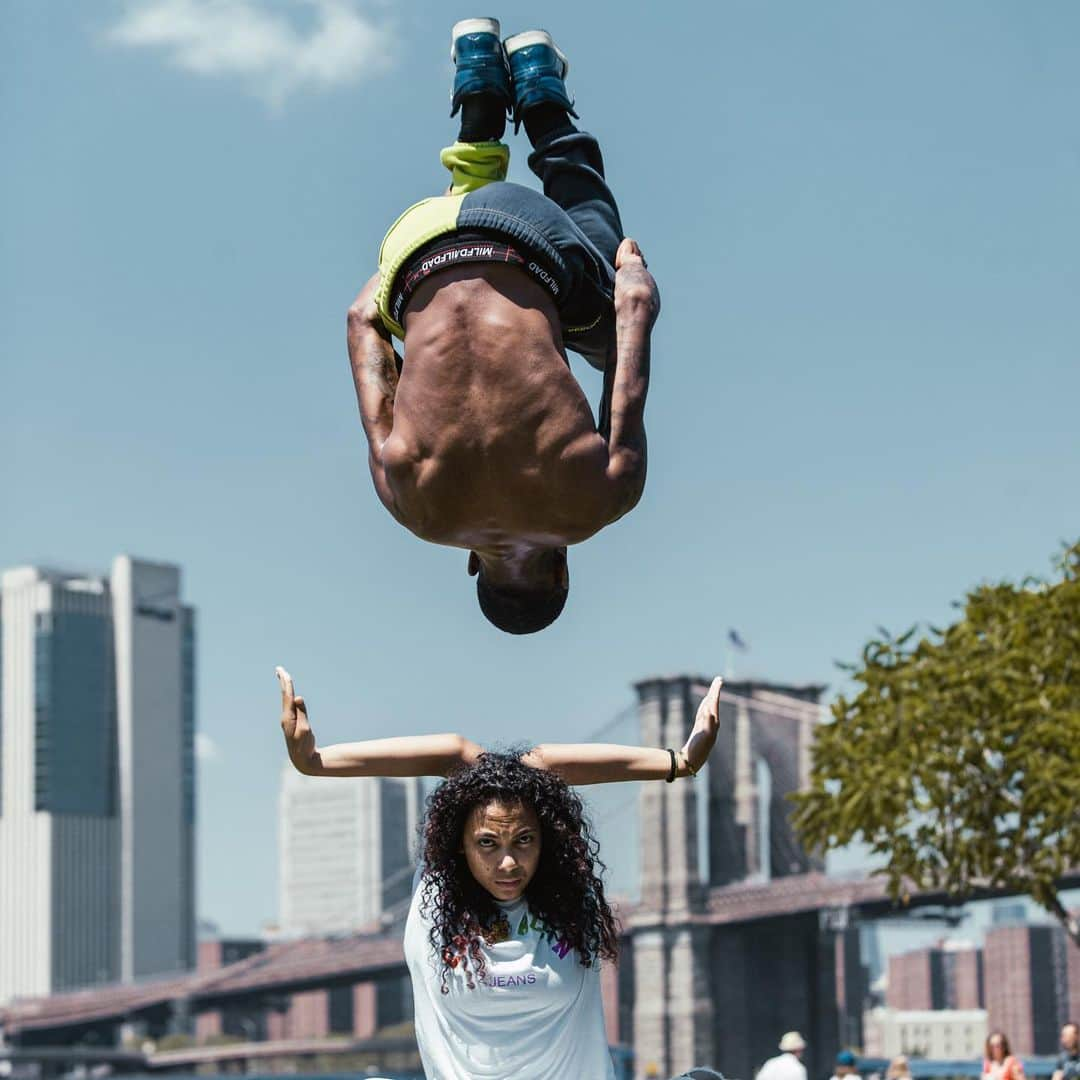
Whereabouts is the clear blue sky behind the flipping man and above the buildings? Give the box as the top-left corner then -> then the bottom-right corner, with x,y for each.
0,0 -> 1080,932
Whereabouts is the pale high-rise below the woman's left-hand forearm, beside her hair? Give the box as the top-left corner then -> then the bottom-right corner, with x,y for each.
279,764 -> 422,934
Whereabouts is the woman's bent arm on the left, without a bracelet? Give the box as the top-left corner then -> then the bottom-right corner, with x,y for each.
274,667 -> 481,777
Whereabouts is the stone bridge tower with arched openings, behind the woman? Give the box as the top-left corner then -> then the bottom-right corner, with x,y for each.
630,675 -> 835,1076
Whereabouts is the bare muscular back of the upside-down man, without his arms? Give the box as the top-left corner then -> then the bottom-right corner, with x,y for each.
382,264 -> 629,550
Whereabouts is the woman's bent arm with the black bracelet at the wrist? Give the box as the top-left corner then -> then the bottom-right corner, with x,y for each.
522,676 -> 723,784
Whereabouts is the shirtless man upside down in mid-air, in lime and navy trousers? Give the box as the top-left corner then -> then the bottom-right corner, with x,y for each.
349,18 -> 660,634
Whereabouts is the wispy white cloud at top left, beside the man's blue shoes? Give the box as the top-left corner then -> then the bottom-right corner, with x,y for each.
108,0 -> 393,105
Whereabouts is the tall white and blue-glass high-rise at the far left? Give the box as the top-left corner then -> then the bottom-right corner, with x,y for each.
0,555 -> 195,1001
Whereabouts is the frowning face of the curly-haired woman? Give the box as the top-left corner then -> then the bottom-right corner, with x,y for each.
461,802 -> 540,901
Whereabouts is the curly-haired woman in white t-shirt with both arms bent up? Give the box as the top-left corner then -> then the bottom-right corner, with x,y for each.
278,667 -> 720,1080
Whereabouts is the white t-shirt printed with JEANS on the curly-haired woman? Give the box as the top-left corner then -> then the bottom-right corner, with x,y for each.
405,874 -> 615,1080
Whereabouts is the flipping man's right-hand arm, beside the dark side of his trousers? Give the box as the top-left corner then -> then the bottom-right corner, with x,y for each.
600,238 -> 660,517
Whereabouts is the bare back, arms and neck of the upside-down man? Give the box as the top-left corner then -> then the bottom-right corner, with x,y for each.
349,240 -> 659,626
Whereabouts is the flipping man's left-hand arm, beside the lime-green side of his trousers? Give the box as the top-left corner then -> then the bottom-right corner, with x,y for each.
347,273 -> 400,519
